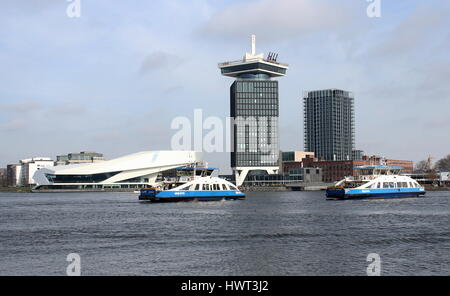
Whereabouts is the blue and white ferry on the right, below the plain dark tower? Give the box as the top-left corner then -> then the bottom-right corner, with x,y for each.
326,165 -> 425,199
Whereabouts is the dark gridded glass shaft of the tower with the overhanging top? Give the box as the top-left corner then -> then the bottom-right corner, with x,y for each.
230,76 -> 279,167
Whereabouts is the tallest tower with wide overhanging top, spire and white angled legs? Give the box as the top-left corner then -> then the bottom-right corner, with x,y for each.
219,35 -> 288,186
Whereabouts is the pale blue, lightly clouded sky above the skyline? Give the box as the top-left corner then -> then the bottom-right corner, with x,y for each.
0,0 -> 450,173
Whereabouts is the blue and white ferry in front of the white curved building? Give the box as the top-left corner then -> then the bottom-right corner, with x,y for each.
139,176 -> 245,202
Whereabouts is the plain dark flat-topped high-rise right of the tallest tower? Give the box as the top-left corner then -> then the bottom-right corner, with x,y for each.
303,89 -> 355,161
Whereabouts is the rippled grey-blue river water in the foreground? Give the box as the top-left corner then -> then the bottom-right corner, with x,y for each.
0,192 -> 450,275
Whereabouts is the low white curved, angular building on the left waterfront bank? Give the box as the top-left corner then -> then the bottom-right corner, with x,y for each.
33,151 -> 201,189
